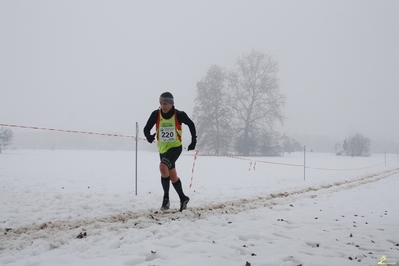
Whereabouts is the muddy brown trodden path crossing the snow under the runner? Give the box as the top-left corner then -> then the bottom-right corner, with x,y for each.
0,168 -> 399,252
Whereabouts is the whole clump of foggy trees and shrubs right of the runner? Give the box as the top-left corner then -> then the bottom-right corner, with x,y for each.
193,50 -> 300,156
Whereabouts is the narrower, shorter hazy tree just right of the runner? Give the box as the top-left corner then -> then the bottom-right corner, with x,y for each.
193,65 -> 231,154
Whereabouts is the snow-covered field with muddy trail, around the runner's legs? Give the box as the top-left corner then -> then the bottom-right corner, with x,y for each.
0,150 -> 399,266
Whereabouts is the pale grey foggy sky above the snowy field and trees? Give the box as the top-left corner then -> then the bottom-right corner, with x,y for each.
0,0 -> 399,142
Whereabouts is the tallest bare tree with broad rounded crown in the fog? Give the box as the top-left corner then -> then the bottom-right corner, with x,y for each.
229,50 -> 285,156
